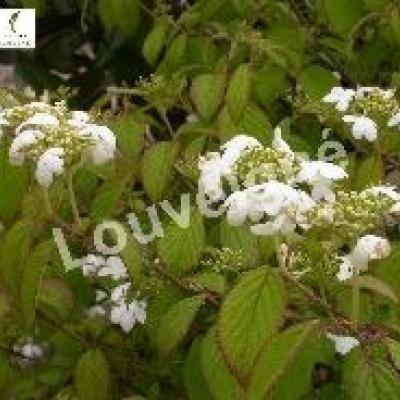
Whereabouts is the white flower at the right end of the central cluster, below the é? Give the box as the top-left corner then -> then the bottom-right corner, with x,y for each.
296,161 -> 347,201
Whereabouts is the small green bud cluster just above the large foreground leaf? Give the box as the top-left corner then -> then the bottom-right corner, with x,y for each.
201,247 -> 244,272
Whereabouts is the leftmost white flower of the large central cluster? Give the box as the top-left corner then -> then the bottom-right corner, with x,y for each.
199,153 -> 225,201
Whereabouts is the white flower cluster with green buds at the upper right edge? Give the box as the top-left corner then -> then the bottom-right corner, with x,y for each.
322,87 -> 400,142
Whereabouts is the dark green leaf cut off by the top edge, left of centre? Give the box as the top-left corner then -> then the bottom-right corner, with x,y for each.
97,0 -> 140,36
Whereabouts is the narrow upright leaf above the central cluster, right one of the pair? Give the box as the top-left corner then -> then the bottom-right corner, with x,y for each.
226,64 -> 251,122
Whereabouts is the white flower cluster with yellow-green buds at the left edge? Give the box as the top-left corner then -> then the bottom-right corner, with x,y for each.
0,102 -> 116,187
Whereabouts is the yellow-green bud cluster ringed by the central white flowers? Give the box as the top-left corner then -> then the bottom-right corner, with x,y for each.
233,147 -> 301,186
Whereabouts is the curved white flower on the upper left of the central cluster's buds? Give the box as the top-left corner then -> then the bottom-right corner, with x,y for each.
221,135 -> 261,176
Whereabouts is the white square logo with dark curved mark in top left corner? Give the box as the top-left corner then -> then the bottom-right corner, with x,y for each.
0,8 -> 36,49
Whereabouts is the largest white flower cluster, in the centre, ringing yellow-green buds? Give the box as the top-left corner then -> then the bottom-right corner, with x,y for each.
199,128 -> 347,235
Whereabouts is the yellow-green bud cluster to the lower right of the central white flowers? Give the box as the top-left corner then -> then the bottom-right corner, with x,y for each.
308,191 -> 394,238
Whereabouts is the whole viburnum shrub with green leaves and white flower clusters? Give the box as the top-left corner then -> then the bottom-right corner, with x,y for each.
0,0 -> 400,400
